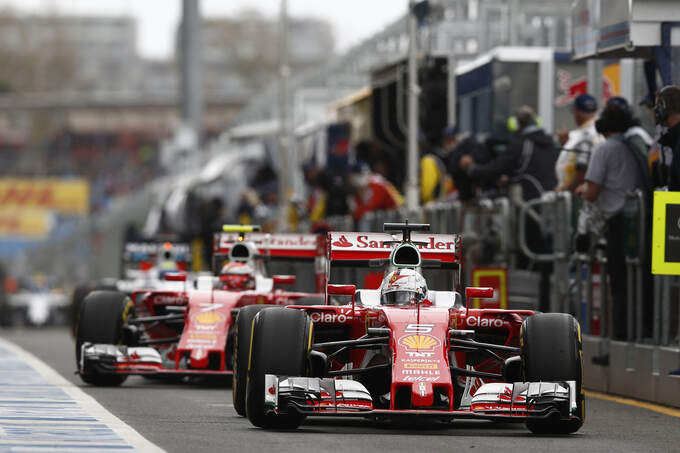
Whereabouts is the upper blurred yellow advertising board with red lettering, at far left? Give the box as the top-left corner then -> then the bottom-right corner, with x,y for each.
0,178 -> 90,215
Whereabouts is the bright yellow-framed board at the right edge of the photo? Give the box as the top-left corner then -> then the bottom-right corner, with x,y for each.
652,192 -> 680,275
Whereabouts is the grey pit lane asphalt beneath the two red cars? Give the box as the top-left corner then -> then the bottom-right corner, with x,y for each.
0,328 -> 680,453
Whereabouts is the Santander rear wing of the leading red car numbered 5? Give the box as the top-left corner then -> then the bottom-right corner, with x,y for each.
327,231 -> 462,265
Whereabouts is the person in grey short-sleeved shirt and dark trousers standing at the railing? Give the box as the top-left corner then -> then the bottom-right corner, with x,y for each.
576,102 -> 649,340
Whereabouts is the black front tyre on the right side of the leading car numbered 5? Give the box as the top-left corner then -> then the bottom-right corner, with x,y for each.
521,313 -> 586,434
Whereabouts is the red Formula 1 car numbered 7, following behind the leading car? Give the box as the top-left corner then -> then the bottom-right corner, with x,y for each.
76,227 -> 324,395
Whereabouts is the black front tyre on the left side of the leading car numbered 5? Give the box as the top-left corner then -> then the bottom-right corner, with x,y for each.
246,307 -> 312,429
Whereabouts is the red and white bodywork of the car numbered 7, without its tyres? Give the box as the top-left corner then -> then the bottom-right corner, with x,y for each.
79,233 -> 325,375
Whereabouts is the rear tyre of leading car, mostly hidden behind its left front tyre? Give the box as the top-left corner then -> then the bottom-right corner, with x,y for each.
232,305 -> 273,417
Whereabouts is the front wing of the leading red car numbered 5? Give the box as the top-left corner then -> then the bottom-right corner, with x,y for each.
264,374 -> 578,422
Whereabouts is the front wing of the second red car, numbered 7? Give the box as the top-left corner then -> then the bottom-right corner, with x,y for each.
78,343 -> 233,376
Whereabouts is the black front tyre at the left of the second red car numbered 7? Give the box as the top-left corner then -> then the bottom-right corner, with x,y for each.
76,291 -> 134,386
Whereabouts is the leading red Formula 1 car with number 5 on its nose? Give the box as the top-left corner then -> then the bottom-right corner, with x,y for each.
237,223 -> 585,433
